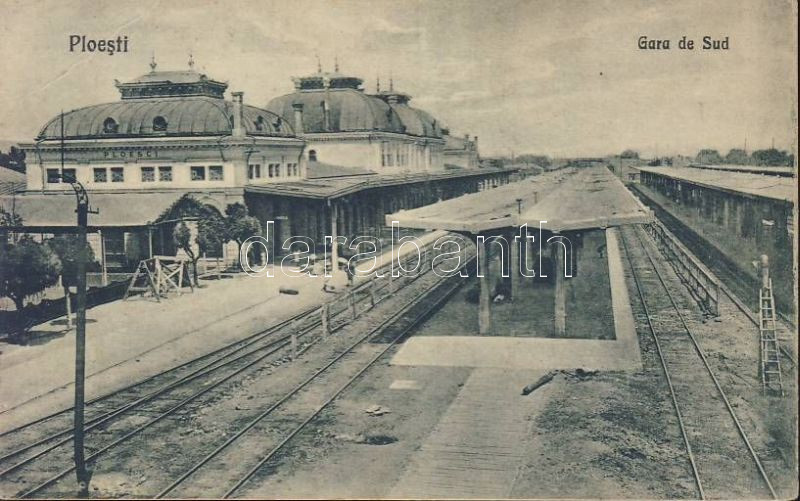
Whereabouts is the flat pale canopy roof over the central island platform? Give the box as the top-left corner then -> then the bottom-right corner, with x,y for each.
386,166 -> 653,233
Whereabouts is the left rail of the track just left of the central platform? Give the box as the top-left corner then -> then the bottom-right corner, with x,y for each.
154,262 -> 462,499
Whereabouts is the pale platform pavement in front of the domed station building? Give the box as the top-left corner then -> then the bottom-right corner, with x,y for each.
0,232 -> 443,432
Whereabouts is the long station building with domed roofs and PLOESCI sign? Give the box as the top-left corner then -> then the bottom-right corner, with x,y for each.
2,61 -> 513,270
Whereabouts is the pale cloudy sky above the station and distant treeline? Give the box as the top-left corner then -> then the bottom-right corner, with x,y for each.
0,0 -> 797,156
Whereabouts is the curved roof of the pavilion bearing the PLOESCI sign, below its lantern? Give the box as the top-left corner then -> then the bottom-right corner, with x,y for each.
38,96 -> 294,139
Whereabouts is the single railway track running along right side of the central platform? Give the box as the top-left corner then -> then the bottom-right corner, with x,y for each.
620,227 -> 777,499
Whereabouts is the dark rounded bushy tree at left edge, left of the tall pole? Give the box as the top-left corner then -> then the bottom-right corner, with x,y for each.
0,236 -> 60,312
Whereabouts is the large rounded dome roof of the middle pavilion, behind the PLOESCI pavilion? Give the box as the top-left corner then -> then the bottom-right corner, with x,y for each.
266,88 -> 404,134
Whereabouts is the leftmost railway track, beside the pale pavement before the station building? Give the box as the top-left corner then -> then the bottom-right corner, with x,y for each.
0,237 -> 468,497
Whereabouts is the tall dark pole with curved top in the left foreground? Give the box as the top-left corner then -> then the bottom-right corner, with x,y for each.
60,174 -> 98,495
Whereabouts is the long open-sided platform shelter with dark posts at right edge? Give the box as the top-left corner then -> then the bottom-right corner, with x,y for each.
637,166 -> 797,314
